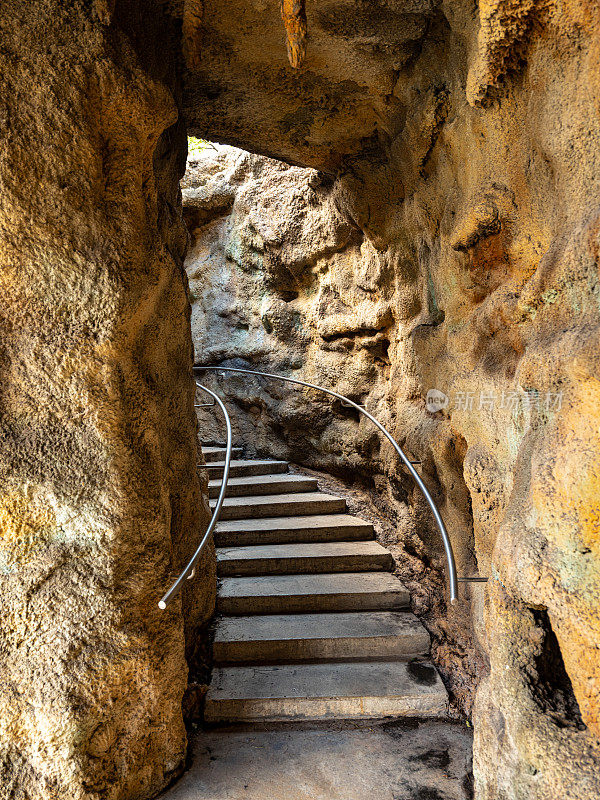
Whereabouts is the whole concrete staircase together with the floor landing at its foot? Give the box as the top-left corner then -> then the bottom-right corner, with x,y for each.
161,447 -> 471,800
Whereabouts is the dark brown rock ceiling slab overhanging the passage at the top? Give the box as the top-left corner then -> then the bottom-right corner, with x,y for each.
184,0 -> 437,170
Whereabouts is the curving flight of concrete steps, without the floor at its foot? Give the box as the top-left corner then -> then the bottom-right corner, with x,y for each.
203,446 -> 447,723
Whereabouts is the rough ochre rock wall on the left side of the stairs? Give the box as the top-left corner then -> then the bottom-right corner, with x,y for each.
0,0 -> 214,800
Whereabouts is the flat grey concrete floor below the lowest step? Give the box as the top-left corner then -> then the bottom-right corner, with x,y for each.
162,720 -> 472,800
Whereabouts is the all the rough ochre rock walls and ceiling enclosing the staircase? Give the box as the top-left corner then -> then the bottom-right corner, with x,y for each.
0,0 -> 600,800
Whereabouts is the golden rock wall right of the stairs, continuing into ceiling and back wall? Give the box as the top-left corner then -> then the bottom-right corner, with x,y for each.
185,0 -> 600,800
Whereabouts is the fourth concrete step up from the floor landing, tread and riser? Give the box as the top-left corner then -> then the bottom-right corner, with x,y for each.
217,540 -> 394,576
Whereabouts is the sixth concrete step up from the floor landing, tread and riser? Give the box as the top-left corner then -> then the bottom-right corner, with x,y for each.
210,492 -> 346,519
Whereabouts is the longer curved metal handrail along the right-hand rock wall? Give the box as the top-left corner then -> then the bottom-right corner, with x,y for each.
194,364 -> 458,604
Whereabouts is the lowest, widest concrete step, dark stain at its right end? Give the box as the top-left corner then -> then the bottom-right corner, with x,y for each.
204,661 -> 448,722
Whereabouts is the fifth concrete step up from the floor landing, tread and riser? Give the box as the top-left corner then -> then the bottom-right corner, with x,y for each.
215,514 -> 375,547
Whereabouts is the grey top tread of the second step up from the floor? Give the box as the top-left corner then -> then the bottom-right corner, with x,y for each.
214,611 -> 429,645
